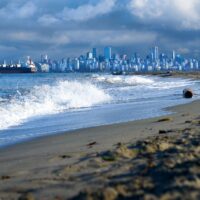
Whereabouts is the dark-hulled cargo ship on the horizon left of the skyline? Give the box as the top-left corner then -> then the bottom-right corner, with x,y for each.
0,57 -> 37,74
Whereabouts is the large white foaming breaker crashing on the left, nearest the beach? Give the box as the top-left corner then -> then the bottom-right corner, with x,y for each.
0,81 -> 111,130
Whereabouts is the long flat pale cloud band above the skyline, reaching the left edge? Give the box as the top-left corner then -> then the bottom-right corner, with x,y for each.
0,30 -> 157,46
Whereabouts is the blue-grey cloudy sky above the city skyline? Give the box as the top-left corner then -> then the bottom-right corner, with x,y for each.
0,0 -> 200,59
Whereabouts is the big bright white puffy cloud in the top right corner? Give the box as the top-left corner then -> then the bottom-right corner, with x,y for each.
128,0 -> 200,29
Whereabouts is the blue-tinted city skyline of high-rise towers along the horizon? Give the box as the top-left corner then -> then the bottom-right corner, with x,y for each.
0,47 -> 200,73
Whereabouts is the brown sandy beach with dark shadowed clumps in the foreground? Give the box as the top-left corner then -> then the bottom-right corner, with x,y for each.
0,101 -> 200,200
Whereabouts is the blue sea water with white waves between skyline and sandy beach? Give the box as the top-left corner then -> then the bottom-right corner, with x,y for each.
0,74 -> 200,147
